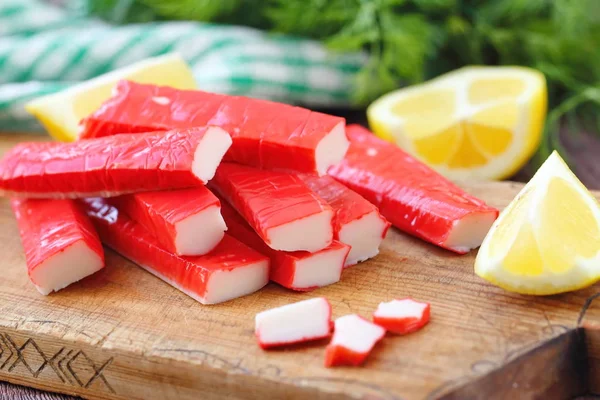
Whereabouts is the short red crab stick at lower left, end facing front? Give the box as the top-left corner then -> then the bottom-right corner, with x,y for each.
11,199 -> 104,295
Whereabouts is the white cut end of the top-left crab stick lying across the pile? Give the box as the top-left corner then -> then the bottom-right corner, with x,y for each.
192,126 -> 232,182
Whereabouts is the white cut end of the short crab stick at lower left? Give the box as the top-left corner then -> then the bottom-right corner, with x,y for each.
30,240 -> 104,295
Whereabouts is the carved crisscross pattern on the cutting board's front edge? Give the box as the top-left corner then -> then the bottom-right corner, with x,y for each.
0,332 -> 115,394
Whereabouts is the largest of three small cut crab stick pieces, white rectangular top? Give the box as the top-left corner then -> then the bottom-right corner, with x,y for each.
254,297 -> 332,349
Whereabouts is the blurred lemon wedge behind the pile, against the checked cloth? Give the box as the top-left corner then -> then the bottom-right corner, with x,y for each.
25,54 -> 196,141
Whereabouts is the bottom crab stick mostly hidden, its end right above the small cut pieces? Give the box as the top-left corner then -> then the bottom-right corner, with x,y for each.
221,201 -> 350,291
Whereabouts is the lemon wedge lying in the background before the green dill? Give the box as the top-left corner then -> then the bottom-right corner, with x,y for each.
367,67 -> 547,179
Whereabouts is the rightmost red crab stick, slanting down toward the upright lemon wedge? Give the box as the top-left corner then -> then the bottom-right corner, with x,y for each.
329,125 -> 498,254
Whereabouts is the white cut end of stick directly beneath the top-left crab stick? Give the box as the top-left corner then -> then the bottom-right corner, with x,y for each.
175,206 -> 227,255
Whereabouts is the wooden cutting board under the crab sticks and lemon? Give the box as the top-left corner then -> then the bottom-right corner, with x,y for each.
0,136 -> 600,399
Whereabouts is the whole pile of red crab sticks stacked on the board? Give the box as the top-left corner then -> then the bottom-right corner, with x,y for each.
0,81 -> 498,306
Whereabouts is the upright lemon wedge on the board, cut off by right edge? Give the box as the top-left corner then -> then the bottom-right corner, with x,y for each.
475,152 -> 600,295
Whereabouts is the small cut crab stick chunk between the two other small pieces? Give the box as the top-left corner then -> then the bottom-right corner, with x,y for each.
325,314 -> 385,367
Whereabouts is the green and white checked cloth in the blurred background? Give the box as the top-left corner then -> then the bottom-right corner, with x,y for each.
0,0 -> 367,131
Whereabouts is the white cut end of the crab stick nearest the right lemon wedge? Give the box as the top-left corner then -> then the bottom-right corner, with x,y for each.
444,212 -> 496,253
